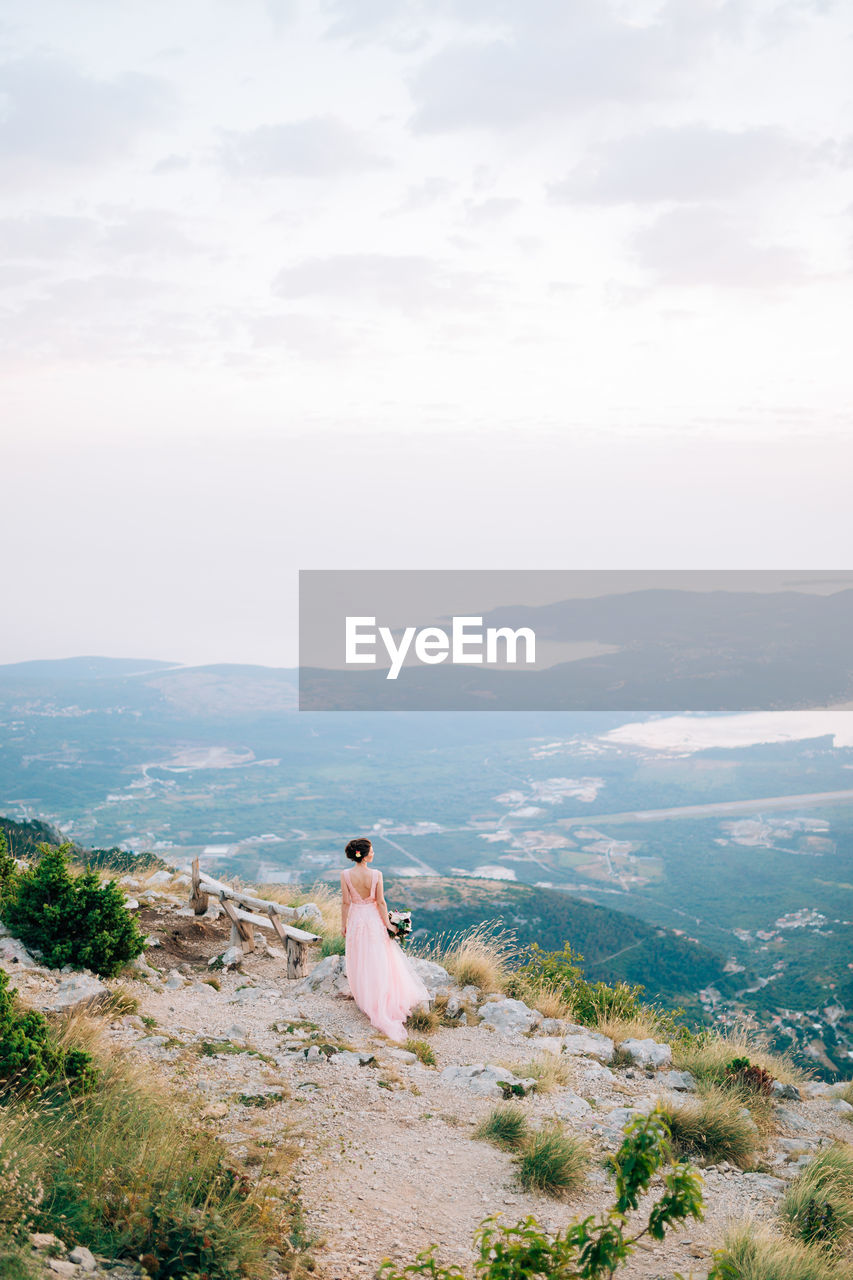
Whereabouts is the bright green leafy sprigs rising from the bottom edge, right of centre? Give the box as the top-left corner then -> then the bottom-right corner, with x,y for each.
378,1112 -> 703,1280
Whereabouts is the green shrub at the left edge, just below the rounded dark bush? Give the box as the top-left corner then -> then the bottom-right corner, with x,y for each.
0,969 -> 97,1096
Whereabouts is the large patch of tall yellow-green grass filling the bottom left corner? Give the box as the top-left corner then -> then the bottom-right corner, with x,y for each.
0,1034 -> 286,1280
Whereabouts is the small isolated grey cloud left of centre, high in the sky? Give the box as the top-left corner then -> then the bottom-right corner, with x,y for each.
219,116 -> 389,178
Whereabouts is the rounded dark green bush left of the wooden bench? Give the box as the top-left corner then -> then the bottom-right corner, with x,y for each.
3,845 -> 145,975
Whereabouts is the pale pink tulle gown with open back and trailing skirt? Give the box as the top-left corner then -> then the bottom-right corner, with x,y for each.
343,870 -> 429,1041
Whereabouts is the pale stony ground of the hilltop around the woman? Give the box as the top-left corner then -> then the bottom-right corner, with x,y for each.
0,877 -> 853,1280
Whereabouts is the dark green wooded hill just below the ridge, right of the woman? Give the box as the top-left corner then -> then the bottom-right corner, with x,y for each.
388,877 -> 743,1015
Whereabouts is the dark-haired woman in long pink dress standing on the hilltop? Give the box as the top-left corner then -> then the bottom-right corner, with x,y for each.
341,838 -> 429,1041
